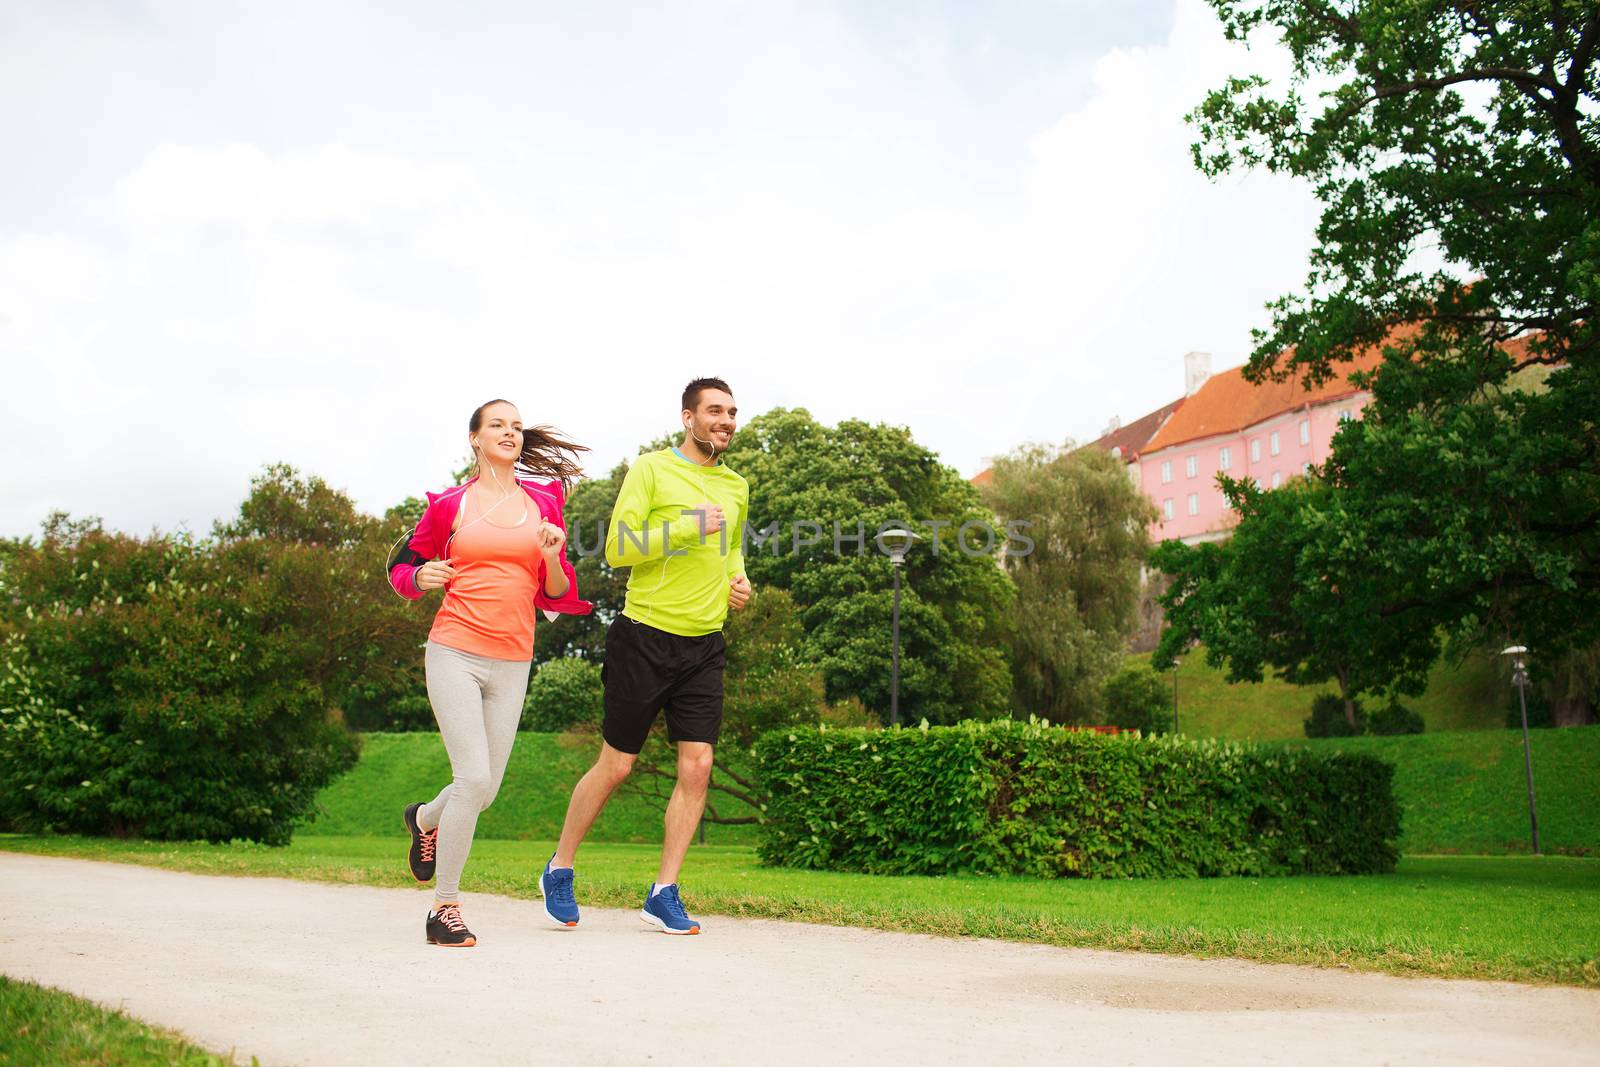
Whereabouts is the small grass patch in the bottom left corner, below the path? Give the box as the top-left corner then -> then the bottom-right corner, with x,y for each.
0,974 -> 243,1067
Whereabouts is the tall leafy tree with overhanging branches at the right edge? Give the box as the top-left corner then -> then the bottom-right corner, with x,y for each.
1190,0 -> 1600,659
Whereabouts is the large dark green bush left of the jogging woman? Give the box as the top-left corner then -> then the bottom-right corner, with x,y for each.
0,517 -> 370,845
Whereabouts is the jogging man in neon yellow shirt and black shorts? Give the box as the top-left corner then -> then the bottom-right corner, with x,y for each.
539,378 -> 750,934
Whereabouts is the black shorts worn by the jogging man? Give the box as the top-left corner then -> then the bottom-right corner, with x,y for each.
600,614 -> 728,755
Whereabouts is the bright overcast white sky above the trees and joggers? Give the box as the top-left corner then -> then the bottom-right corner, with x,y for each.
0,0 -> 1317,536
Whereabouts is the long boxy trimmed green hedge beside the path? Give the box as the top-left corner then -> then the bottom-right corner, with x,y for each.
755,720 -> 1400,878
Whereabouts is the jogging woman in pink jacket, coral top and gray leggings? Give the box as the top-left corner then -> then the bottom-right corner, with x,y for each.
389,400 -> 590,947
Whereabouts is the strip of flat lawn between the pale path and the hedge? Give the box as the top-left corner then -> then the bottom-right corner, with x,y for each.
0,832 -> 1600,987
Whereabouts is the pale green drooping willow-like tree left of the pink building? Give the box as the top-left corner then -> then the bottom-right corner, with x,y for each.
982,445 -> 1155,723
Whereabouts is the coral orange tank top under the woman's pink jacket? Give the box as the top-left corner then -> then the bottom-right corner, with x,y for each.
427,490 -> 544,661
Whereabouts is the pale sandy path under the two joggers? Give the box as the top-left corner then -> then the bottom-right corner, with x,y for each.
0,853 -> 1600,1067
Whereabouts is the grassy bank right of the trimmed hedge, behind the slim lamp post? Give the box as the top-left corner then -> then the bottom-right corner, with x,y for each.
1285,726 -> 1600,856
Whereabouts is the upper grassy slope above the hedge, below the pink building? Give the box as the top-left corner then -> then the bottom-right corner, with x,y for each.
1130,649 -> 1512,741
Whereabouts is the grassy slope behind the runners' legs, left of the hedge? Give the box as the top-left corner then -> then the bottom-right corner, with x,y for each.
301,733 -> 755,845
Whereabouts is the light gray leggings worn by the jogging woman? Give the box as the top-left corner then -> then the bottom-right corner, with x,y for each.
416,641 -> 531,902
